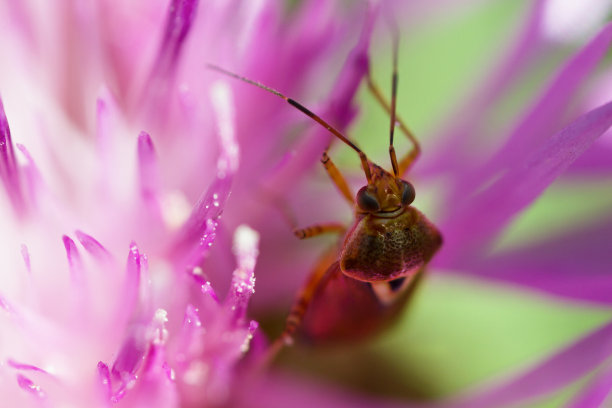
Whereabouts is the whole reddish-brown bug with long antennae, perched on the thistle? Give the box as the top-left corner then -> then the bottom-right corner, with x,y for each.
209,31 -> 442,351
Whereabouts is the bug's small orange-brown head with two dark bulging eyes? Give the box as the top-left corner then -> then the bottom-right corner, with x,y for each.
355,163 -> 415,213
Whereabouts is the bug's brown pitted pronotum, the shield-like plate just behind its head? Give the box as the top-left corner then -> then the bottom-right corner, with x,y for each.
340,207 -> 442,282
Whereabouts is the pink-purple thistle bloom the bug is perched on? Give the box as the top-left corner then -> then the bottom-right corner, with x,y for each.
0,0 -> 612,407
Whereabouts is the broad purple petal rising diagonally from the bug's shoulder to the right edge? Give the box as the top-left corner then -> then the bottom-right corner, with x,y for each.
435,102 -> 612,265
